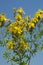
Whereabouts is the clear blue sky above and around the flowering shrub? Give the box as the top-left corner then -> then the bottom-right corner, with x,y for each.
0,0 -> 43,65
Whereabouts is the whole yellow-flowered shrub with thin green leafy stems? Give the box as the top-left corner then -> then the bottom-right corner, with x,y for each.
0,8 -> 43,65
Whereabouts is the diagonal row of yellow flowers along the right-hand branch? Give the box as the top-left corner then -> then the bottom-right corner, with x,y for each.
28,10 -> 43,29
